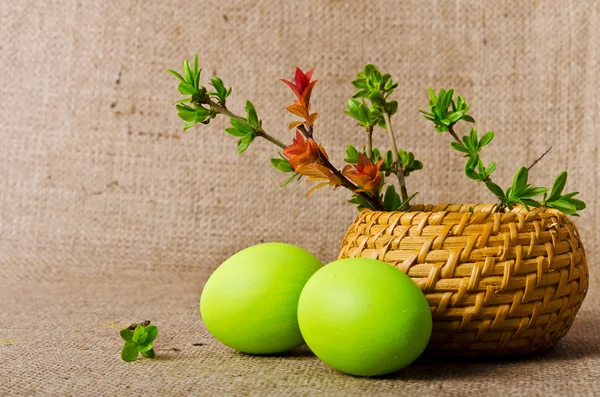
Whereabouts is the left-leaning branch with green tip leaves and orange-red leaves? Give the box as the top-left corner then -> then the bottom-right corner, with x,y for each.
169,55 -> 384,210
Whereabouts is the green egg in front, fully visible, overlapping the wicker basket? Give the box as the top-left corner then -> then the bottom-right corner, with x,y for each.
298,258 -> 432,376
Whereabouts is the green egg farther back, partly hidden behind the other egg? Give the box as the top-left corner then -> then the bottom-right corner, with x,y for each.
200,243 -> 322,354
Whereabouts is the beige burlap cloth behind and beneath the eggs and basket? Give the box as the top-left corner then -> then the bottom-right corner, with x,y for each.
0,0 -> 600,395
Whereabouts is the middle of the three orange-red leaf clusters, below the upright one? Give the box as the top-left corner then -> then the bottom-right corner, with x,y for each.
283,130 -> 342,196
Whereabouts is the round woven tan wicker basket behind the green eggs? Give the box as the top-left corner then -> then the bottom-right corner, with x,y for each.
339,204 -> 588,357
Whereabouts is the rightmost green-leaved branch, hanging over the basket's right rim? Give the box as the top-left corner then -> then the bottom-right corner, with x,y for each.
420,88 -> 585,215
